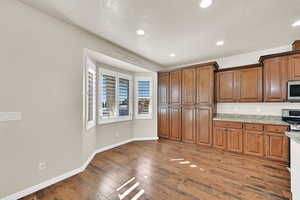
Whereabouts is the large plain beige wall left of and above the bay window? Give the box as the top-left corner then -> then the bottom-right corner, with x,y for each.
0,0 -> 160,199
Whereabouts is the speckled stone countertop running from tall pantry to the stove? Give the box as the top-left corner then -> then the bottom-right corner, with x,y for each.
213,113 -> 289,126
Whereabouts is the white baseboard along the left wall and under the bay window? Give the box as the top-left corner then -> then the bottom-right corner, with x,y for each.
1,137 -> 158,200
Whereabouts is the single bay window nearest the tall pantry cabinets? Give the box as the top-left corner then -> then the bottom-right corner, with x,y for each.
135,77 -> 152,119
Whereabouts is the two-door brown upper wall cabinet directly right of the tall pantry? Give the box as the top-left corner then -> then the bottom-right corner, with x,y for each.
217,65 -> 262,102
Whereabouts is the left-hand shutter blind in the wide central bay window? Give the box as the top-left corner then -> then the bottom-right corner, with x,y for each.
101,75 -> 116,118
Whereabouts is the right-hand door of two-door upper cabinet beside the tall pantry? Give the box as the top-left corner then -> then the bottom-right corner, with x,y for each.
237,67 -> 262,102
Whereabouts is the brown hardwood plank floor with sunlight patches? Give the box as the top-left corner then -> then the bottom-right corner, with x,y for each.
23,140 -> 290,200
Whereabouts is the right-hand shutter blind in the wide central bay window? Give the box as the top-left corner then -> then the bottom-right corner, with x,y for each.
118,78 -> 129,116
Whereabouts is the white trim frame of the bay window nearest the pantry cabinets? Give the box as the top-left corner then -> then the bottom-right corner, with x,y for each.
134,76 -> 153,119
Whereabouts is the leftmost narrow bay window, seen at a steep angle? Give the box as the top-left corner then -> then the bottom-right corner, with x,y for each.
85,58 -> 96,130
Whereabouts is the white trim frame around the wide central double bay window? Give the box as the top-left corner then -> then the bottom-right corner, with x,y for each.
98,68 -> 133,125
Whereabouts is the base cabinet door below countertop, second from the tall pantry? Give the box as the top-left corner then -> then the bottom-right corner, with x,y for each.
227,128 -> 243,153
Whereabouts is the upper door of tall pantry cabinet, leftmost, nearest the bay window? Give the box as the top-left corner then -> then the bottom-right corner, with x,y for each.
158,73 -> 169,105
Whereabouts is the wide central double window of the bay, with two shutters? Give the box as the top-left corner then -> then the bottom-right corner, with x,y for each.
99,69 -> 132,124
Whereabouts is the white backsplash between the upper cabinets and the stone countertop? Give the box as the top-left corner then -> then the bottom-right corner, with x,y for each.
217,103 -> 300,116
